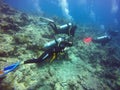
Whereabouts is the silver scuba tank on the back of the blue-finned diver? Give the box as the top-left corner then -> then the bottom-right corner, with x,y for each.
43,38 -> 64,49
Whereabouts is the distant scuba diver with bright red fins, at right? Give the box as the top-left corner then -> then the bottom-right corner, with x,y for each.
83,30 -> 119,46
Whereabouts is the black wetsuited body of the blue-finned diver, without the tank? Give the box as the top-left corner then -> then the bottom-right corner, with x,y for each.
24,41 -> 72,64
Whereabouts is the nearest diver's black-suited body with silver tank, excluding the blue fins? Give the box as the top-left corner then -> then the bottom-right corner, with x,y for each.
24,38 -> 73,64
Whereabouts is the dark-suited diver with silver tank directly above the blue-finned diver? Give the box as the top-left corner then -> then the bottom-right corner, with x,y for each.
49,22 -> 77,36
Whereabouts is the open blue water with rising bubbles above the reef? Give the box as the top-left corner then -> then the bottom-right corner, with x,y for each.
5,0 -> 120,26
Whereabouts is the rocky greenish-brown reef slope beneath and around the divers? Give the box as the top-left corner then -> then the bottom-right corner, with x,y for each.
0,0 -> 120,90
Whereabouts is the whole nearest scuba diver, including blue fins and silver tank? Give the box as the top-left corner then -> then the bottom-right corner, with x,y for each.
0,38 -> 73,80
